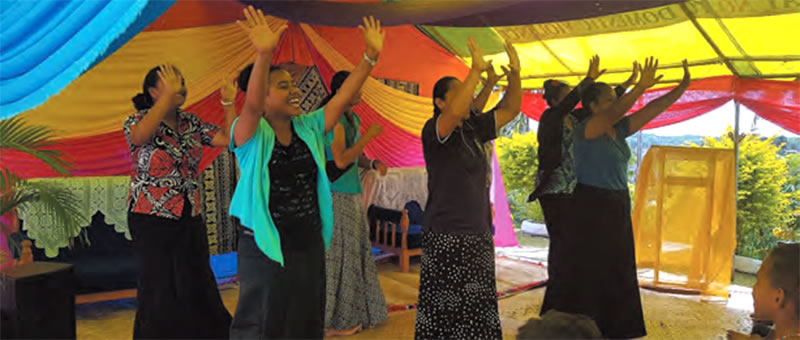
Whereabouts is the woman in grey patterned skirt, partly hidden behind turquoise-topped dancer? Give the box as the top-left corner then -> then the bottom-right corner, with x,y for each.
323,71 -> 387,336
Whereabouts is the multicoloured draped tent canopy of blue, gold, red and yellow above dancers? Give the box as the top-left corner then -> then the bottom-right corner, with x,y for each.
0,0 -> 800,177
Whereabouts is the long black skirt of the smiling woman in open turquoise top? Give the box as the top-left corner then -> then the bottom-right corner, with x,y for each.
231,226 -> 326,339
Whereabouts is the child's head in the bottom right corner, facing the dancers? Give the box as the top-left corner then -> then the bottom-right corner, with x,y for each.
728,243 -> 800,340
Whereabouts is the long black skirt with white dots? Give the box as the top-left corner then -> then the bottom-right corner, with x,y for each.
414,232 -> 503,339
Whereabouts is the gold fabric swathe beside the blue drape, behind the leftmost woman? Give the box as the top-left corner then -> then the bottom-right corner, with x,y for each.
15,19 -> 281,137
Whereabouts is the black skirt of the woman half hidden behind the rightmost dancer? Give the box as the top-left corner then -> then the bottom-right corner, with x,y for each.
539,194 -> 576,315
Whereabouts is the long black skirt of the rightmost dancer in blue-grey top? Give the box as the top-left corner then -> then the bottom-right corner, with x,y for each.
560,184 -> 647,339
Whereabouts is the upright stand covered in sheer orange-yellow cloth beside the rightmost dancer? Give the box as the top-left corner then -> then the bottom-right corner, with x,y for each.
632,146 -> 736,297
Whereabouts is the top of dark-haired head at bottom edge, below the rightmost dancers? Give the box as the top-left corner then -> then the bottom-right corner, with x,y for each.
517,309 -> 603,340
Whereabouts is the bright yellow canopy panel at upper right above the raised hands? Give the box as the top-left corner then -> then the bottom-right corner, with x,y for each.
456,6 -> 800,89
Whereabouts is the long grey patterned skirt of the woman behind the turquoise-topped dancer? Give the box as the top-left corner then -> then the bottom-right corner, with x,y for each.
325,192 -> 387,330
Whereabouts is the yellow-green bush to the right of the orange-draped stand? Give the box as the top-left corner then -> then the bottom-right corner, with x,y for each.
693,128 -> 792,259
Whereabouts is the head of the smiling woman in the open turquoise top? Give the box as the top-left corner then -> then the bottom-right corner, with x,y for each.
238,64 -> 303,116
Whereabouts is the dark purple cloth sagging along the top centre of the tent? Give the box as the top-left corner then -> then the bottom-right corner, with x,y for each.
242,0 -> 683,27
